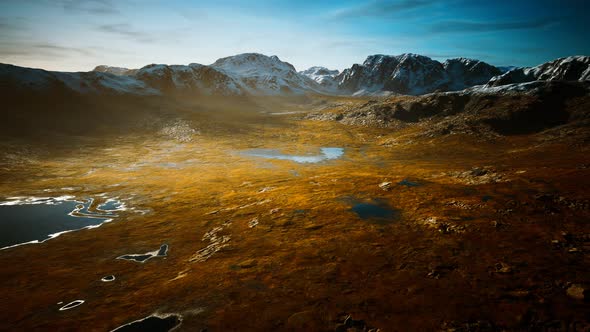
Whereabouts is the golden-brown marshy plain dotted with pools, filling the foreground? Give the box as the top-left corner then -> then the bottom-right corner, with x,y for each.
0,95 -> 590,331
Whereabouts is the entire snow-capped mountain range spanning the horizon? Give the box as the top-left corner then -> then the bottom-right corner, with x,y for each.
0,53 -> 590,96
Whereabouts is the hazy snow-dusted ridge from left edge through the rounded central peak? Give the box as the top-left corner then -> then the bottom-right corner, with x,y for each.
0,53 -> 323,96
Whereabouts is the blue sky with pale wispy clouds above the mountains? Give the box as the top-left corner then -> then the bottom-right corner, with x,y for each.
0,0 -> 590,71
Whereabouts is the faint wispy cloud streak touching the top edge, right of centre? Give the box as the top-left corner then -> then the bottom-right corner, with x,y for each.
331,0 -> 437,19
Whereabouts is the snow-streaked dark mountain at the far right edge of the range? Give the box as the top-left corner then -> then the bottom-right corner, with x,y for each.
487,55 -> 590,87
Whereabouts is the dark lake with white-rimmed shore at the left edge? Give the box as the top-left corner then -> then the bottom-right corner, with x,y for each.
0,196 -> 122,250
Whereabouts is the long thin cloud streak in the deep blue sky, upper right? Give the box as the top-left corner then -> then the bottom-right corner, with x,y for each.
429,18 -> 559,33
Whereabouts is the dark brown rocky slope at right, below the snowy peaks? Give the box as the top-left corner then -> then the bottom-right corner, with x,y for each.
307,81 -> 590,143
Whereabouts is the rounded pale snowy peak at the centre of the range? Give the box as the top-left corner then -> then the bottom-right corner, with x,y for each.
210,53 -> 321,95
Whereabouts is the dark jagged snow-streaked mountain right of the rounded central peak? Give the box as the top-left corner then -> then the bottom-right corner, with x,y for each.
336,53 -> 501,95
